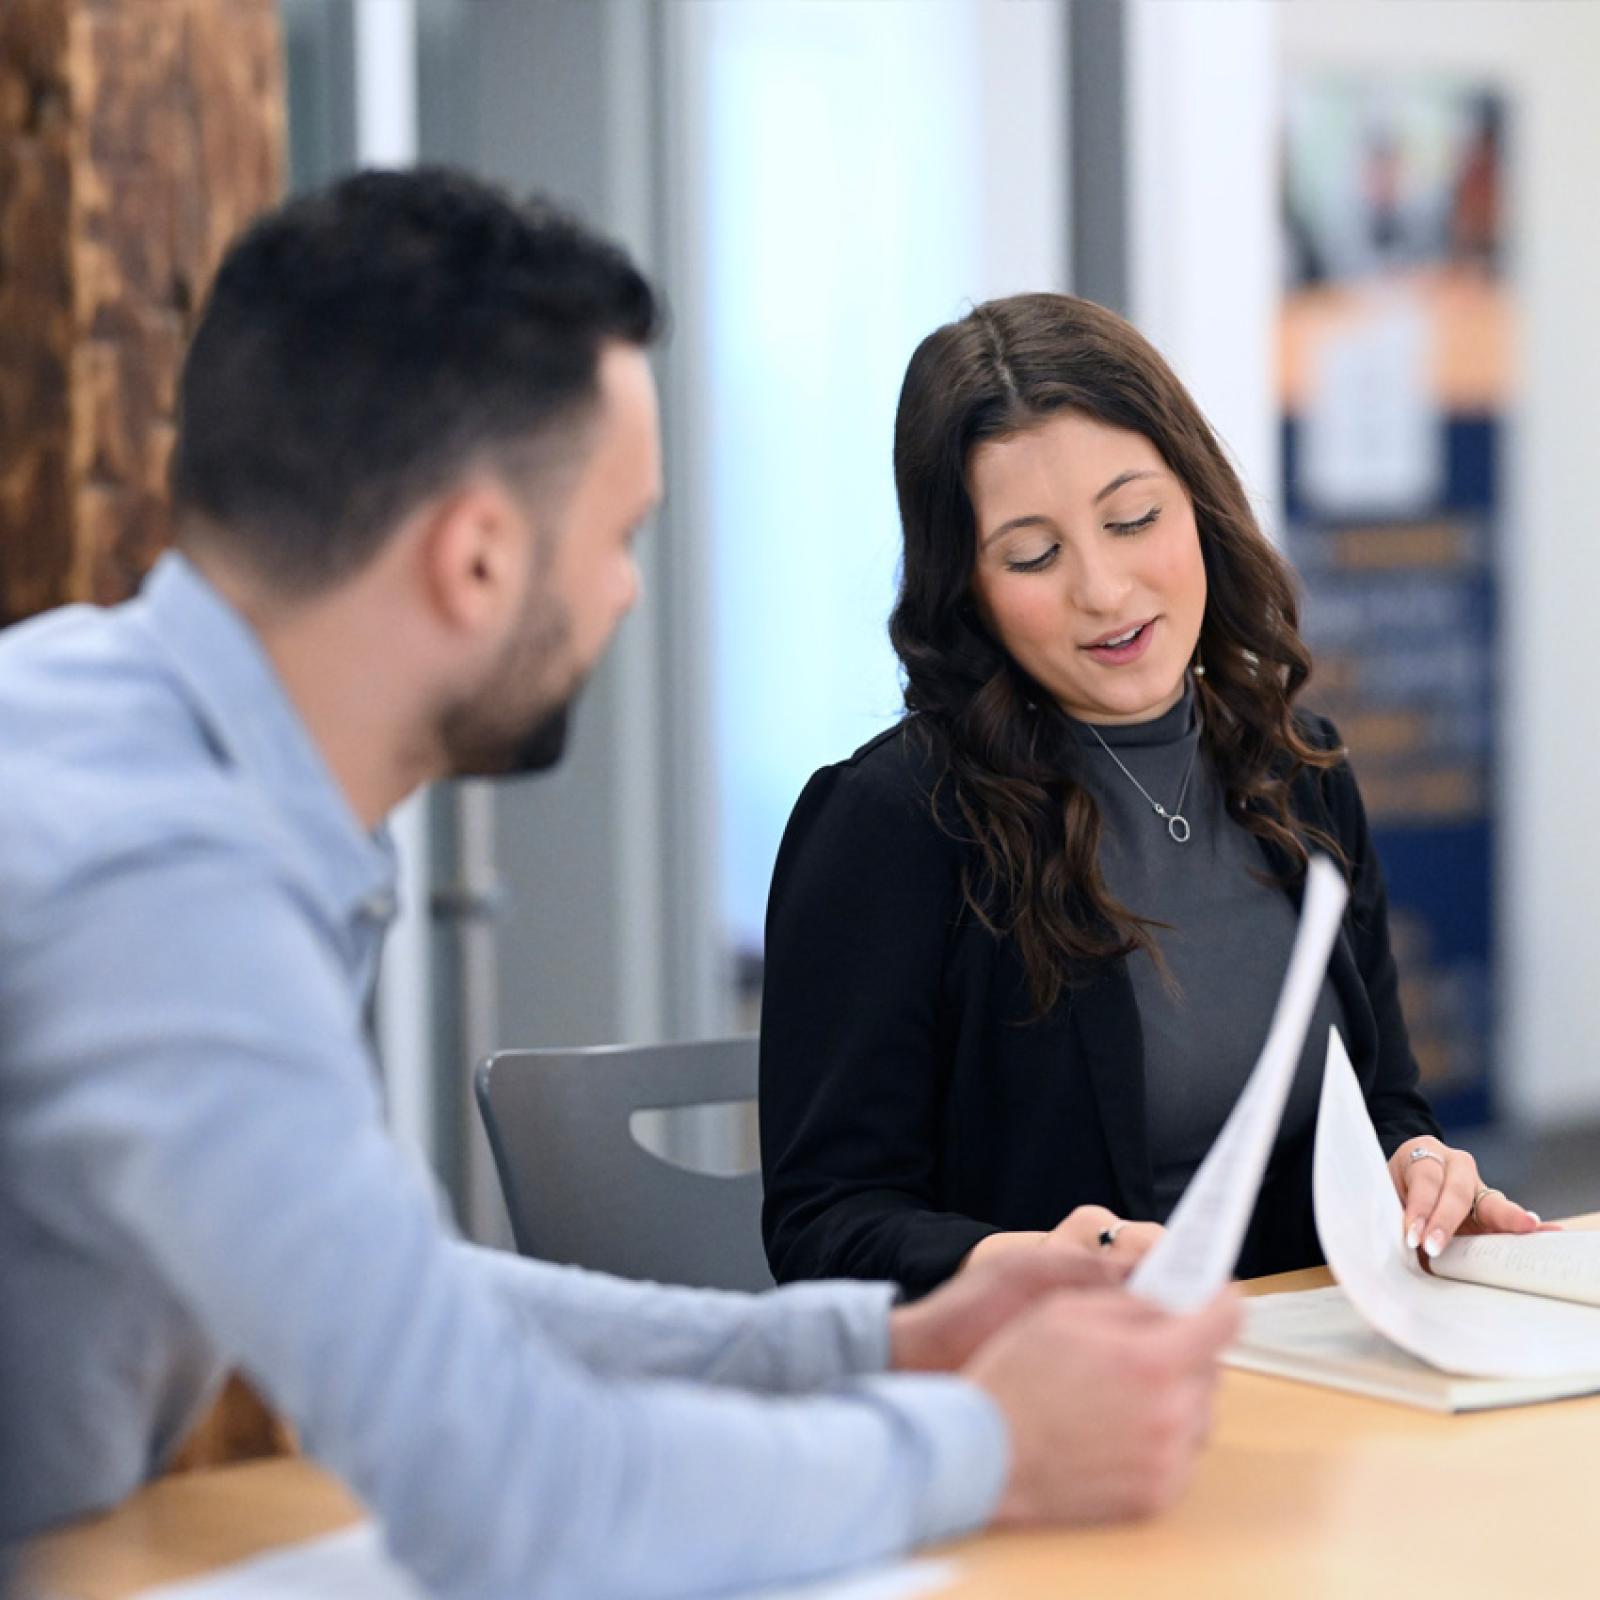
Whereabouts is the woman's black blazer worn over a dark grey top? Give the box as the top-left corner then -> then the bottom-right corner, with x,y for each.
760,717 -> 1438,1294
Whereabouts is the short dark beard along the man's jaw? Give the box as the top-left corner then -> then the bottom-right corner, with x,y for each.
440,585 -> 582,778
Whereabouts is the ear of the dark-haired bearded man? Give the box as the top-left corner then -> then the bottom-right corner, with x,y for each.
418,478 -> 534,634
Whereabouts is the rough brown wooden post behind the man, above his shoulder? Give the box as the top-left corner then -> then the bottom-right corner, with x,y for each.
0,0 -> 285,622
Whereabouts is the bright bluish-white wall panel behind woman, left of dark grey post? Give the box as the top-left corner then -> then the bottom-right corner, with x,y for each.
669,0 -> 1067,949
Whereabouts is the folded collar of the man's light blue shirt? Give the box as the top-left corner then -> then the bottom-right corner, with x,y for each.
134,550 -> 395,922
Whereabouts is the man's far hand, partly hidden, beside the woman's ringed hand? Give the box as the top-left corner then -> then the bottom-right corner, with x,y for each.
890,1243 -> 1130,1373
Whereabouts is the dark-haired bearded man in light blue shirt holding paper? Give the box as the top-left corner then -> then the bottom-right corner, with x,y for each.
0,171 -> 1235,1597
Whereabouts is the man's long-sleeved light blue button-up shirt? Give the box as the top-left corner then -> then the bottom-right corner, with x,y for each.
0,555 -> 1006,1600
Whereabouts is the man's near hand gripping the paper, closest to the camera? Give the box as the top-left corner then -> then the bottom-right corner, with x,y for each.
965,1290 -> 1238,1526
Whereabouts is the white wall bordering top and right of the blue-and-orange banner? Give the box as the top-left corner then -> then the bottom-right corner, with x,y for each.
1280,0 -> 1600,1125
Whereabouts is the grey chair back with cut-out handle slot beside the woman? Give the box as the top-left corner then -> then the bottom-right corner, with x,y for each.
475,1038 -> 773,1290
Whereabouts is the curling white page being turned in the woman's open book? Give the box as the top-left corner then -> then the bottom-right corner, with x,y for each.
1312,1030 -> 1600,1378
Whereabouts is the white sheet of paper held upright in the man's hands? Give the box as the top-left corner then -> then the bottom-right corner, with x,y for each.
1128,856 -> 1349,1312
